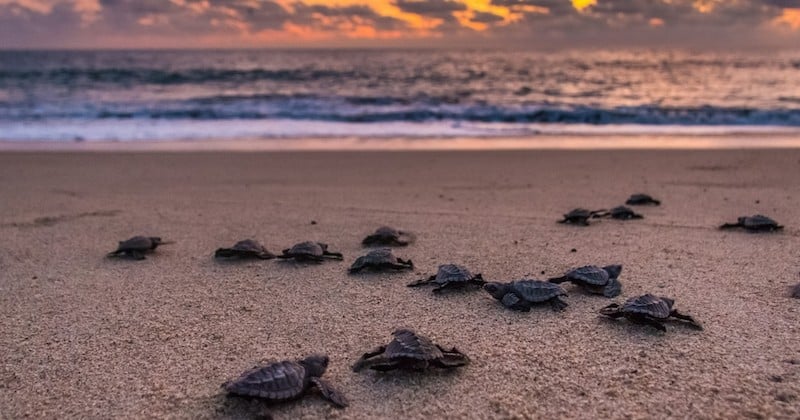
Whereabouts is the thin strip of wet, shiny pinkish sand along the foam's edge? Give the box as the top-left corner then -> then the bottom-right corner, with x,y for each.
0,133 -> 800,152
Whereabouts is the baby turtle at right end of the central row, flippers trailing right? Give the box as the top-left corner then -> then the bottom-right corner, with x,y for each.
600,294 -> 703,331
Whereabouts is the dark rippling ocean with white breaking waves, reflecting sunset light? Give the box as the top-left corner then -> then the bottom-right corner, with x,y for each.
0,50 -> 800,142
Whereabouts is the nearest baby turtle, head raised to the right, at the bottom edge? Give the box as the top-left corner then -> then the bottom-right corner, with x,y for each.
223,354 -> 347,408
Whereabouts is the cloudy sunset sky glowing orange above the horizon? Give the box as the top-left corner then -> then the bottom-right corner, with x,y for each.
0,0 -> 800,49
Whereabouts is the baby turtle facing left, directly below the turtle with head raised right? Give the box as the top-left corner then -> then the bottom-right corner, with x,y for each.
483,280 -> 569,312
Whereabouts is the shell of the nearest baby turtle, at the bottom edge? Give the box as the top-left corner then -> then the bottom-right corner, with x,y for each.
225,361 -> 310,401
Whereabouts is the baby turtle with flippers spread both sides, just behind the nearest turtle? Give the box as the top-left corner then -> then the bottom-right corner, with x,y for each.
353,329 -> 469,372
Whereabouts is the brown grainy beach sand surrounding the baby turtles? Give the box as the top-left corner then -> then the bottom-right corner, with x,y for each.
0,150 -> 800,419
